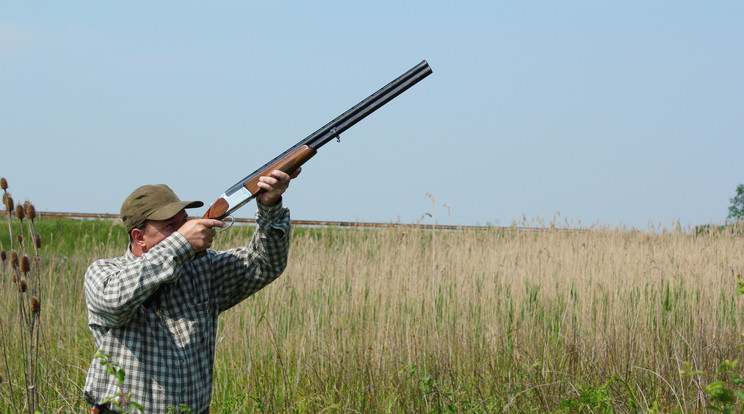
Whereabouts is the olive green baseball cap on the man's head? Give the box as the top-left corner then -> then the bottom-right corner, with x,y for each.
121,184 -> 204,233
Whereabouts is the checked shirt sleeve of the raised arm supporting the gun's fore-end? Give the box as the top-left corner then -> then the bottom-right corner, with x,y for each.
212,202 -> 291,311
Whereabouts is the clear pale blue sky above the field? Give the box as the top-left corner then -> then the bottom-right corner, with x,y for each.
0,0 -> 744,229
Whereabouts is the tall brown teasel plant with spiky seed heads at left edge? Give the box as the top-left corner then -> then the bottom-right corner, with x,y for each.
0,178 -> 45,414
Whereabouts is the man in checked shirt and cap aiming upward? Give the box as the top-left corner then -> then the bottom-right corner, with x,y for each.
84,168 -> 300,414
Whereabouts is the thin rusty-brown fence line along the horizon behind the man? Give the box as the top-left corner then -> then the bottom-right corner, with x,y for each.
27,211 -> 524,231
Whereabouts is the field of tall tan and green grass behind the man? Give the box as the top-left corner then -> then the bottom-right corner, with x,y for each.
0,212 -> 744,413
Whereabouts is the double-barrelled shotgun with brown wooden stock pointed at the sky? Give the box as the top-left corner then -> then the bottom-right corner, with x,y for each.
203,60 -> 432,220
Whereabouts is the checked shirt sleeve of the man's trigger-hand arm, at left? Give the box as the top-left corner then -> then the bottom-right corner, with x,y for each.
85,232 -> 194,328
